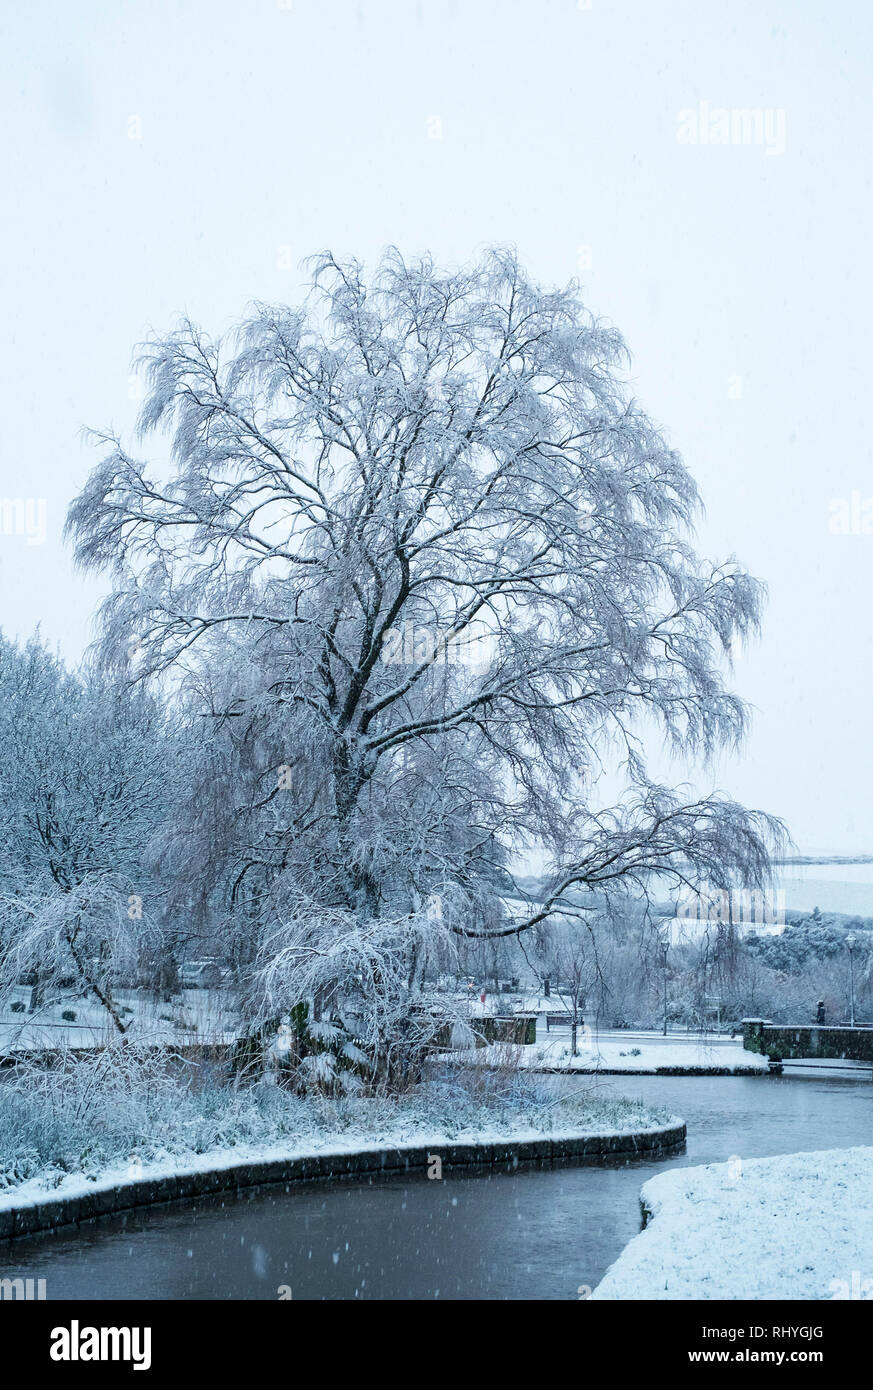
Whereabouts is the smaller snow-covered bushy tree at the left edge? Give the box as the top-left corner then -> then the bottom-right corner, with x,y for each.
0,637 -> 168,1031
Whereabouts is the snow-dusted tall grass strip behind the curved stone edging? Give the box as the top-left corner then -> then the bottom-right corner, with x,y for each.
0,1047 -> 670,1205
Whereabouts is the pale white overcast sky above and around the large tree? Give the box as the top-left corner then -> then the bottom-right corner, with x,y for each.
0,0 -> 873,852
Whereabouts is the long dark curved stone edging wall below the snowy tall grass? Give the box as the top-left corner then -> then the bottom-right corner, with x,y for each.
0,1120 -> 687,1241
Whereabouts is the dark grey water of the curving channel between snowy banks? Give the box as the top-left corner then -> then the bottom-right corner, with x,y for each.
0,1073 -> 873,1300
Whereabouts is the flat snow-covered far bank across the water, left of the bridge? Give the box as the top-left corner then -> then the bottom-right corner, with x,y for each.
463,1029 -> 767,1074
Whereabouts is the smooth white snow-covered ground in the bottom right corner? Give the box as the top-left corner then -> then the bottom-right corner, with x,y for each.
592,1148 -> 873,1300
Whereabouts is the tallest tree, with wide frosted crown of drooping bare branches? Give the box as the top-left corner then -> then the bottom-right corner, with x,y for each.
68,250 -> 778,1028
